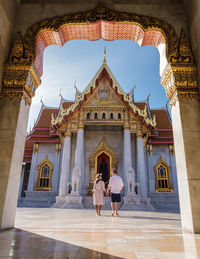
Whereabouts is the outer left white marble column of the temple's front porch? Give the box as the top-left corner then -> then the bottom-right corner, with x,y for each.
59,132 -> 71,196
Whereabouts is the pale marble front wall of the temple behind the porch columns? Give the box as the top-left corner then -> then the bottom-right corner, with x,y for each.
23,130 -> 178,211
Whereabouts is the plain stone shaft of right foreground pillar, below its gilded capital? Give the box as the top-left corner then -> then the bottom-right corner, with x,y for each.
172,97 -> 200,233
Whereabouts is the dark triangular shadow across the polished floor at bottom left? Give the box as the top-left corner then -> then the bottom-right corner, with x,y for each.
0,228 -> 121,259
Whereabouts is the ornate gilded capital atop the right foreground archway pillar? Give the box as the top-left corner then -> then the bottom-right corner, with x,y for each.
161,30 -> 199,106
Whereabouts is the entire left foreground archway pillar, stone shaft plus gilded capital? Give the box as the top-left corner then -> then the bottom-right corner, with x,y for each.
0,33 -> 40,229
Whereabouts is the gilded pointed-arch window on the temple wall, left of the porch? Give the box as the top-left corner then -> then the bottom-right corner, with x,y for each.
34,156 -> 54,191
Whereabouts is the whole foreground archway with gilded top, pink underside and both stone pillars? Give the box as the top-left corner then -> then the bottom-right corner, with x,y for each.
0,6 -> 200,232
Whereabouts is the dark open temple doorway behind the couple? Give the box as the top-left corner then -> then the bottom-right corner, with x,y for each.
97,152 -> 110,187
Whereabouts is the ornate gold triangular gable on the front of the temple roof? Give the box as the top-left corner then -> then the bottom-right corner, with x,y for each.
51,62 -> 156,130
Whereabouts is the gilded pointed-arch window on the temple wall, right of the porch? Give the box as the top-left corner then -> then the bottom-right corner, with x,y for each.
153,157 -> 174,192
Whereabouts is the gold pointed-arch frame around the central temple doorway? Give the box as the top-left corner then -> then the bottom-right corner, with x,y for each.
89,138 -> 118,193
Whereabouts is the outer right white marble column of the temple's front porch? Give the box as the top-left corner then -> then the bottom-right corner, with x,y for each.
137,131 -> 147,197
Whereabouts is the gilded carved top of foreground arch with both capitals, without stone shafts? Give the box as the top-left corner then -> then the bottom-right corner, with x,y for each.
1,5 -> 199,105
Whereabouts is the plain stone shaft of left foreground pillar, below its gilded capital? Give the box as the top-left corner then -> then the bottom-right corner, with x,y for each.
0,97 -> 30,229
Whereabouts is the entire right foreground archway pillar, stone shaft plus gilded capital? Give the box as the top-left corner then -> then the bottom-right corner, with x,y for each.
161,55 -> 200,233
